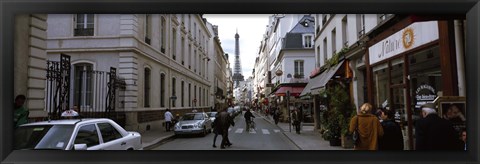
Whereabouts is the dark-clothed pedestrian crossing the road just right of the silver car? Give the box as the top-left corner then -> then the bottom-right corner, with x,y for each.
215,109 -> 235,149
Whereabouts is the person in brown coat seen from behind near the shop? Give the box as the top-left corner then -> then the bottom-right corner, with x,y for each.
349,103 -> 383,150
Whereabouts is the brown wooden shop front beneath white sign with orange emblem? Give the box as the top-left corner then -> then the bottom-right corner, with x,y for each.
366,18 -> 464,150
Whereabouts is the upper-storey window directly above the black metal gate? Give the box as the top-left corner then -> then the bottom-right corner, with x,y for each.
73,14 -> 94,36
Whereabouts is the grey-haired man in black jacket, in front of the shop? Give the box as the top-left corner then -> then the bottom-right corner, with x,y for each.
415,103 -> 462,150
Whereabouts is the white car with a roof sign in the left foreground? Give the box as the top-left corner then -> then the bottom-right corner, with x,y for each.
14,118 -> 143,150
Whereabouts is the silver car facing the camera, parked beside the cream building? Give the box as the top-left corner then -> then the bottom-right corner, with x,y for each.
174,112 -> 212,136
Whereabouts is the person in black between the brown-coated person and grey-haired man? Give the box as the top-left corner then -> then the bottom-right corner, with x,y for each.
377,109 -> 403,150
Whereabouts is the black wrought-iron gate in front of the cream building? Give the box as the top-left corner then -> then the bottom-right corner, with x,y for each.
46,54 -> 125,125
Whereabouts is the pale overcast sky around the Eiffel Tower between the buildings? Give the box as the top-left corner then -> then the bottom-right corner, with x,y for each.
203,14 -> 271,79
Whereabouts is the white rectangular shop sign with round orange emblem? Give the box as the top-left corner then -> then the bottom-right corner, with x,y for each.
368,21 -> 438,64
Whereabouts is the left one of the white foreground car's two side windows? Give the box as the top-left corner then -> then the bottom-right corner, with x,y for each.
74,124 -> 100,147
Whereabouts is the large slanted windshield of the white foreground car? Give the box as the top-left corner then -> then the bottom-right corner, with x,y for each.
14,125 -> 74,150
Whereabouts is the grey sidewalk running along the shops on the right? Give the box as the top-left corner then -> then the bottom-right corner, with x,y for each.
261,115 -> 353,150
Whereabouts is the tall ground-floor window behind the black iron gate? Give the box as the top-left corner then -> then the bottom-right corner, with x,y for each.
73,63 -> 94,109
